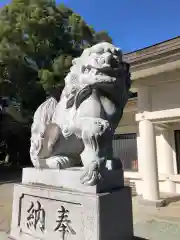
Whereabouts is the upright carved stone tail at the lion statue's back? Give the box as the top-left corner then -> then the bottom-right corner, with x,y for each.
30,97 -> 58,167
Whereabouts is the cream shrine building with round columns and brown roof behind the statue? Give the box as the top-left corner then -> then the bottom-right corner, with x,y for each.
113,37 -> 180,201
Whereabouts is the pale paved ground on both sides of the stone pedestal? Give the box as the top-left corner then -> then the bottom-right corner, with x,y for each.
0,183 -> 180,240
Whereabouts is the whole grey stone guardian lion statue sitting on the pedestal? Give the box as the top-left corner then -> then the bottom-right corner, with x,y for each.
30,42 -> 131,185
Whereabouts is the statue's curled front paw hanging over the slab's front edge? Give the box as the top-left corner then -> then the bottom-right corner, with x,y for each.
80,162 -> 102,186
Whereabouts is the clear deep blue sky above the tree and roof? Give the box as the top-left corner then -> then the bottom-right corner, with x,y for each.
0,0 -> 180,52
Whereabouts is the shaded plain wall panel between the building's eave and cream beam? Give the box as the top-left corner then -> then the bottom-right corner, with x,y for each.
151,81 -> 180,111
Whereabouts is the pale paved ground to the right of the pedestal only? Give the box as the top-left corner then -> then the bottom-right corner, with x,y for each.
133,197 -> 180,240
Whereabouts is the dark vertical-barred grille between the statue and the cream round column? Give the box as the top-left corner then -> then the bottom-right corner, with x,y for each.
113,133 -> 138,171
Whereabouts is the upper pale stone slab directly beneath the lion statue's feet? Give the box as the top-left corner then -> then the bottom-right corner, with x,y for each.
22,167 -> 124,193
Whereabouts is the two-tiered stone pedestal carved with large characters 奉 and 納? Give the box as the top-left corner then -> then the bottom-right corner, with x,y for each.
10,169 -> 133,240
